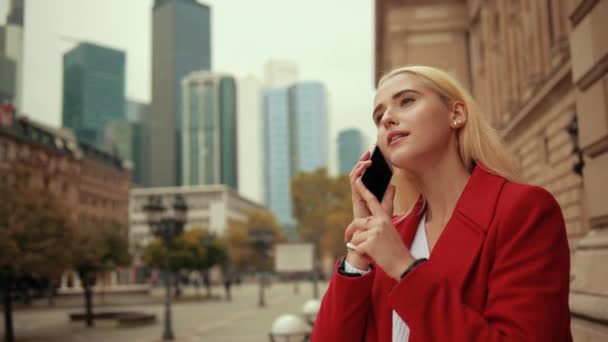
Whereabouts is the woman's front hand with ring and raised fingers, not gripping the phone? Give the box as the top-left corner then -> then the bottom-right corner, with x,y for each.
344,176 -> 415,281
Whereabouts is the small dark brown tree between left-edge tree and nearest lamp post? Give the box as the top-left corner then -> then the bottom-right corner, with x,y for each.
72,222 -> 131,327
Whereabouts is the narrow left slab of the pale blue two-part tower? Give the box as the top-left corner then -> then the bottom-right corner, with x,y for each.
263,88 -> 294,227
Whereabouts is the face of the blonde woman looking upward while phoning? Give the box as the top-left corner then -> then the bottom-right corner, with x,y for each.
373,73 -> 466,170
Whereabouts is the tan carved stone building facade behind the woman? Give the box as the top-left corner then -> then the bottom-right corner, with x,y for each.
375,0 -> 608,341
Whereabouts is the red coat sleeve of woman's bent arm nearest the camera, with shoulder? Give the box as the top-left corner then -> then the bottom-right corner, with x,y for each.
389,186 -> 572,341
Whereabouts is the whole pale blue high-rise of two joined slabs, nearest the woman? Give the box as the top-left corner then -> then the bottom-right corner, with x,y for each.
263,82 -> 328,234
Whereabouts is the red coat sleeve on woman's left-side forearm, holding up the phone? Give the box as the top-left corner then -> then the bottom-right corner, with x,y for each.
310,261 -> 375,342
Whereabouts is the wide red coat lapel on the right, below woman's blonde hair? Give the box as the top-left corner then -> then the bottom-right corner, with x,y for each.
426,166 -> 506,287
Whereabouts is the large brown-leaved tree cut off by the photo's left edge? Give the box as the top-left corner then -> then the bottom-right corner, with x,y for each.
0,167 -> 73,342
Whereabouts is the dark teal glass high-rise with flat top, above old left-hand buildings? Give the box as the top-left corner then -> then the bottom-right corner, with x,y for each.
63,43 -> 125,145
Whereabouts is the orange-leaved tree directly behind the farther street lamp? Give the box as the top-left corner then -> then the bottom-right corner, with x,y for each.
226,211 -> 287,271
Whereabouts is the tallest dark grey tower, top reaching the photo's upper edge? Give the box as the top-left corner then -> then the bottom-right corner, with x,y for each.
146,0 -> 211,186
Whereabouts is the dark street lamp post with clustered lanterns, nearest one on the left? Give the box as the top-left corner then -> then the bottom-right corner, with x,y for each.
143,195 -> 188,341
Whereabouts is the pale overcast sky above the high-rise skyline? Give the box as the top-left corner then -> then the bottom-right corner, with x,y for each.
0,0 -> 375,172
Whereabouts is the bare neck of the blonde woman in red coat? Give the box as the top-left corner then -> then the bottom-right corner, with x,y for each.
415,154 -> 471,229
